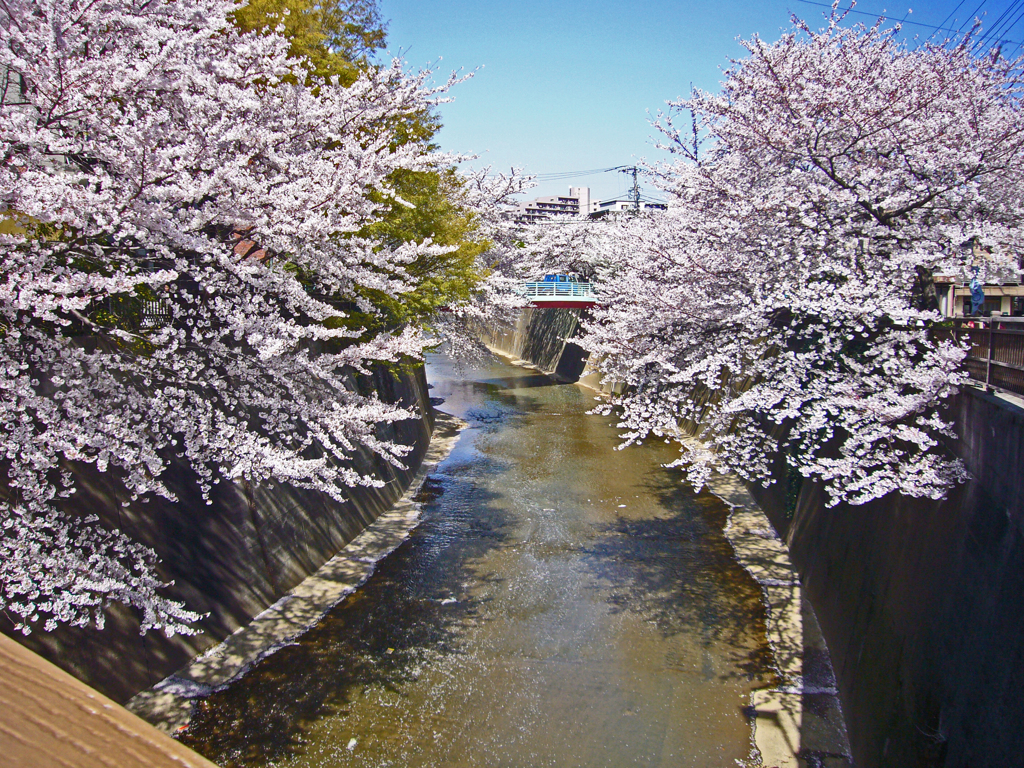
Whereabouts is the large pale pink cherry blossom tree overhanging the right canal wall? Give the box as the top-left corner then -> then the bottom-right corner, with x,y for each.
573,8 -> 1024,512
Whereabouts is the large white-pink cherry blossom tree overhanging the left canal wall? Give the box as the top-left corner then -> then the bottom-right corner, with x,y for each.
0,0 -> 503,633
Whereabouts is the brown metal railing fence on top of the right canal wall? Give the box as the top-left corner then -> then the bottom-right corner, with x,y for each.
952,316 -> 1024,396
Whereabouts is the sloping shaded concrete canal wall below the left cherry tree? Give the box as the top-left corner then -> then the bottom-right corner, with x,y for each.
0,365 -> 433,702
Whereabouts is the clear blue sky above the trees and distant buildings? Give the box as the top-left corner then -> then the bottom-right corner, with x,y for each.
380,0 -> 1024,199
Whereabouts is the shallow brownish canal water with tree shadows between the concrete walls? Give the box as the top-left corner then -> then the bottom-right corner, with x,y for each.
182,357 -> 773,768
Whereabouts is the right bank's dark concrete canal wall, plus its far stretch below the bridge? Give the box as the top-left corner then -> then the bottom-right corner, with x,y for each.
486,309 -> 1024,768
